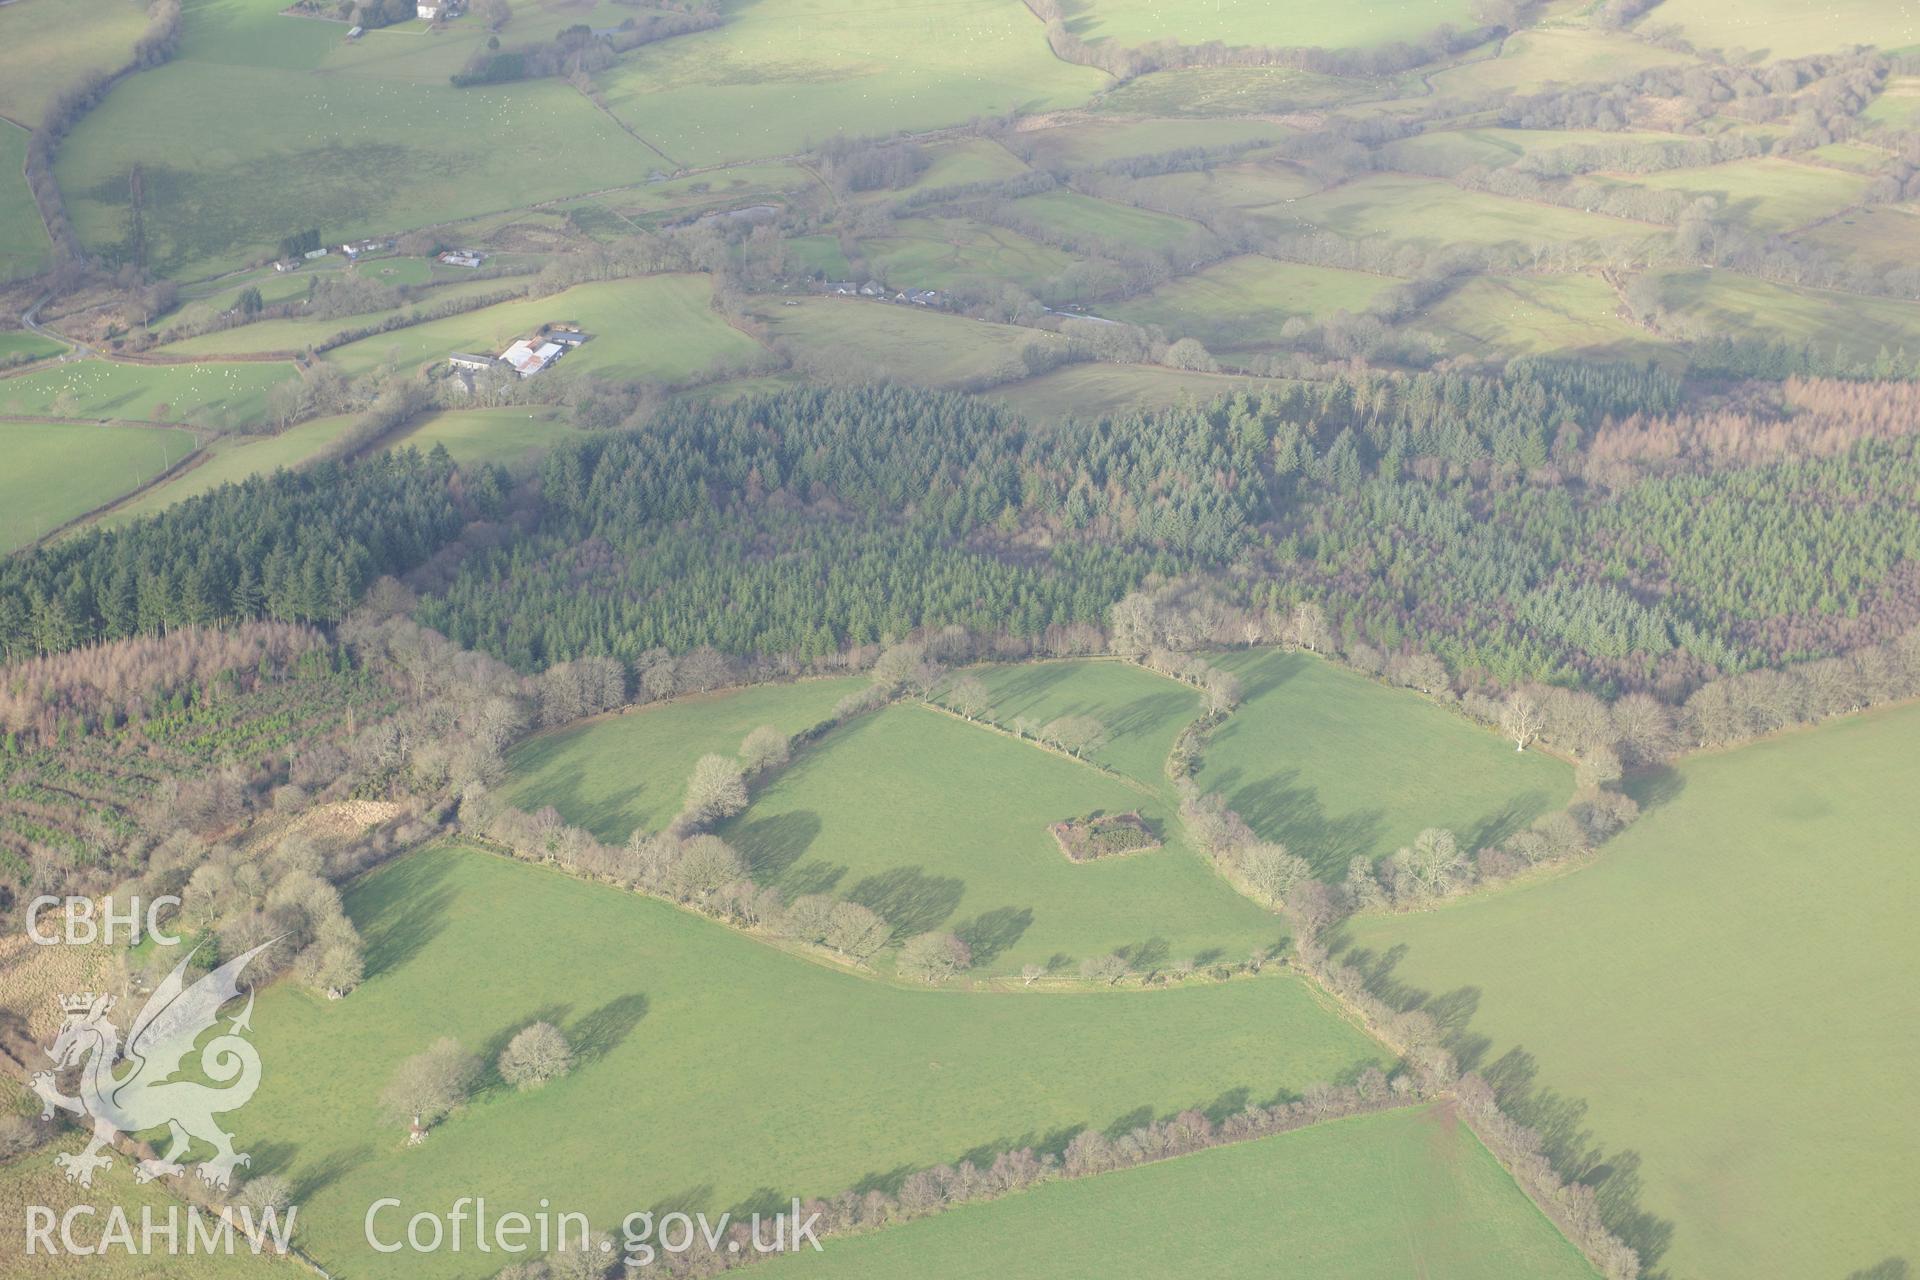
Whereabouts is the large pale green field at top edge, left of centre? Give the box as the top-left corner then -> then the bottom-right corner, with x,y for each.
597,0 -> 1108,169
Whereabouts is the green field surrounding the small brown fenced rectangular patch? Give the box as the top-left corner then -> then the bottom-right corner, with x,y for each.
722,702 -> 1288,975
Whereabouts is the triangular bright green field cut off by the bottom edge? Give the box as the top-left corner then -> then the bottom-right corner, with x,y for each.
768,1105 -> 1594,1280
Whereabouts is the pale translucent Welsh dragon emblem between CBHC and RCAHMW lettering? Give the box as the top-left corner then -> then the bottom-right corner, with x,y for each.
33,942 -> 273,1190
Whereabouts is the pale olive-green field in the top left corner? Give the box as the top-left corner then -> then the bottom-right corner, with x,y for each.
0,0 -> 146,129
